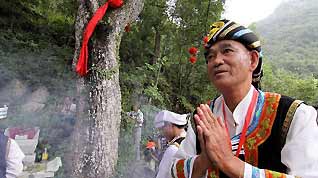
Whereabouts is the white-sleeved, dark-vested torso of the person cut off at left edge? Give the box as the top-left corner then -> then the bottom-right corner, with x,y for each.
0,133 -> 24,178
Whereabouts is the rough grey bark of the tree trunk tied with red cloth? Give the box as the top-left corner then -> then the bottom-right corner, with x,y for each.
70,0 -> 143,178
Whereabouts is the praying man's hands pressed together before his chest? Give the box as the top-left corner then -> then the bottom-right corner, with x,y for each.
194,104 -> 244,177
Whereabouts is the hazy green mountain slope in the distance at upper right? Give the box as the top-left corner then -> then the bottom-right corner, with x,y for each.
256,0 -> 318,75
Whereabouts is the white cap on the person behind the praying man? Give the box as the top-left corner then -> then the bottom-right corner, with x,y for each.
155,110 -> 187,128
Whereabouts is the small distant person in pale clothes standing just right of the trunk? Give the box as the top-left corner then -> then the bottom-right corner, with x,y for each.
127,105 -> 144,160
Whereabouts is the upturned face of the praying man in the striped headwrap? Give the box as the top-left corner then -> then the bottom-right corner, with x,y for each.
206,40 -> 255,89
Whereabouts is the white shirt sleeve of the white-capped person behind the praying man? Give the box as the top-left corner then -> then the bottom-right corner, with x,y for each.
156,132 -> 186,178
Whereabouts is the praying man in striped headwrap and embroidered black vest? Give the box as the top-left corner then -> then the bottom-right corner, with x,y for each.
171,20 -> 318,178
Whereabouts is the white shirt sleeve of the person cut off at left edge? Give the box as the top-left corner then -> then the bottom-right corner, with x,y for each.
6,139 -> 25,178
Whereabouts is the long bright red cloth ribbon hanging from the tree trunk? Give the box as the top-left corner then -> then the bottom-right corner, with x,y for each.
76,0 -> 123,76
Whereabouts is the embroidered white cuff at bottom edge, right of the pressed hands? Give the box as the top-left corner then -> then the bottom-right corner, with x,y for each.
244,163 -> 299,178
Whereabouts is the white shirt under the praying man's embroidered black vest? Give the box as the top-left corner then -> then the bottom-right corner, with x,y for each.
175,86 -> 318,178
